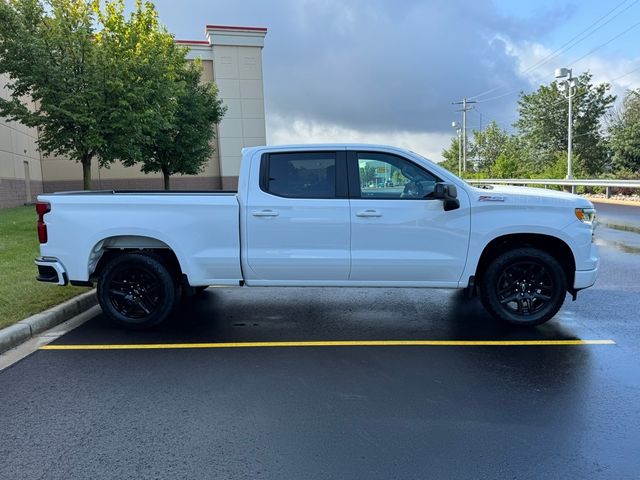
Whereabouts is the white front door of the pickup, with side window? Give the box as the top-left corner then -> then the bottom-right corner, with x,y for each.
348,152 -> 470,286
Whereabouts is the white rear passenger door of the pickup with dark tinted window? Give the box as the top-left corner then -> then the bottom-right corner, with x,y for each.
245,150 -> 351,285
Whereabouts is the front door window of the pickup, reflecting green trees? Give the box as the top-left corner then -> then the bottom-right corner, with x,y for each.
358,152 -> 438,199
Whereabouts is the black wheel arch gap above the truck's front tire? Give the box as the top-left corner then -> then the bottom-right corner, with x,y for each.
475,233 -> 576,291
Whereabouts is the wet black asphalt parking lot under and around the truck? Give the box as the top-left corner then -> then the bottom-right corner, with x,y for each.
0,201 -> 640,479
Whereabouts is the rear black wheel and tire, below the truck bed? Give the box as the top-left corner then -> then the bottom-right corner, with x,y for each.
98,253 -> 179,330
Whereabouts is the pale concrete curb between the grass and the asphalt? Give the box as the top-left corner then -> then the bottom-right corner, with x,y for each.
0,290 -> 98,353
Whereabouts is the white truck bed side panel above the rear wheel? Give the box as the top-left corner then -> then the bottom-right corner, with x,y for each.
38,190 -> 242,285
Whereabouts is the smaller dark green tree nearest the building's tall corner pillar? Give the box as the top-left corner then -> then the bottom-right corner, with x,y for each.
125,62 -> 226,190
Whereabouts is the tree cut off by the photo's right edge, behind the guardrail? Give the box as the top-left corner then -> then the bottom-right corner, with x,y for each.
609,89 -> 640,173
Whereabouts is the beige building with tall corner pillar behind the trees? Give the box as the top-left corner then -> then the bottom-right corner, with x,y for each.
0,25 -> 267,207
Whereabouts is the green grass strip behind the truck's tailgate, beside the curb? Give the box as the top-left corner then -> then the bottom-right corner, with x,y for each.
0,206 -> 87,328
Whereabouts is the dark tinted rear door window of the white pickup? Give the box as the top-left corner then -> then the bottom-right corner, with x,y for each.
265,152 -> 336,198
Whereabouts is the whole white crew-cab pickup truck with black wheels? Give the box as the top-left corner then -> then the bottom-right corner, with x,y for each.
36,144 -> 599,328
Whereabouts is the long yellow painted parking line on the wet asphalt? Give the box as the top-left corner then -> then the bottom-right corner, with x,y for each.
40,340 -> 616,350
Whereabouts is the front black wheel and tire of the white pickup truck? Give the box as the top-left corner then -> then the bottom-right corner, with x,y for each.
480,248 -> 567,326
